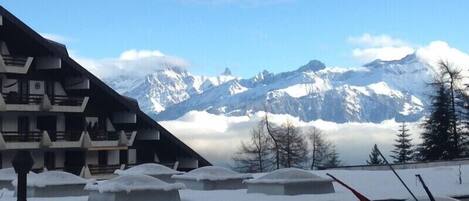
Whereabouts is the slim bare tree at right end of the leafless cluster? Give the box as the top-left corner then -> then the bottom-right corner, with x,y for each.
306,127 -> 332,170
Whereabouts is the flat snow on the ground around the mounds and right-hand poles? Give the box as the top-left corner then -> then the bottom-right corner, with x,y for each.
0,165 -> 469,201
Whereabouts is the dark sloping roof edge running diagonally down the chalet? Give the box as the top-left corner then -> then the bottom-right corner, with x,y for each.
0,6 -> 211,166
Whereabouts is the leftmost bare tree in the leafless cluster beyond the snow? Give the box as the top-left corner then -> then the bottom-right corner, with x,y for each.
233,122 -> 272,172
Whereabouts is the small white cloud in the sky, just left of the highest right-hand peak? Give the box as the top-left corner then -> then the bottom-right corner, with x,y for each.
347,33 -> 415,62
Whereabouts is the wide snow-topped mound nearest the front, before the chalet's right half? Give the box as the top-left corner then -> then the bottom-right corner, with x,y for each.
85,175 -> 185,193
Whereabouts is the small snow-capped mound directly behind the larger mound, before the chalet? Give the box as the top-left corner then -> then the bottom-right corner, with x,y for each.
114,163 -> 183,176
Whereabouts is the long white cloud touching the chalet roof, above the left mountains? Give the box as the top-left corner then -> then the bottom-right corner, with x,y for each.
71,49 -> 189,78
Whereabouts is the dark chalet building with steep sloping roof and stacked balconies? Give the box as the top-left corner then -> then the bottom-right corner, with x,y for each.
0,6 -> 210,174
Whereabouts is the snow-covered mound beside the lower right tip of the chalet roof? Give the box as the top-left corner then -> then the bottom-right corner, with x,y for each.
172,166 -> 252,181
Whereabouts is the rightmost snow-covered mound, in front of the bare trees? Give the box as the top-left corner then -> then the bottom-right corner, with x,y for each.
245,168 -> 331,184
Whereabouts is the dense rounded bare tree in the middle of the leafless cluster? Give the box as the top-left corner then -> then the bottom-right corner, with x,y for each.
276,121 -> 308,168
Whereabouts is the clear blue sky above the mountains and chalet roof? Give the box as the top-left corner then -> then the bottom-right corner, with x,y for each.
2,0 -> 469,77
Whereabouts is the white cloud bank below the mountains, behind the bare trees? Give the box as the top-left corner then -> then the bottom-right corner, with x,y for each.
160,111 -> 420,165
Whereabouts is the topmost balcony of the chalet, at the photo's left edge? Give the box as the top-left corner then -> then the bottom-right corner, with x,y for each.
0,55 -> 33,74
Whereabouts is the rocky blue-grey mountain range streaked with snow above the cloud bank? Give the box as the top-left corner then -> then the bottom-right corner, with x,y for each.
105,54 -> 434,122
